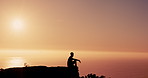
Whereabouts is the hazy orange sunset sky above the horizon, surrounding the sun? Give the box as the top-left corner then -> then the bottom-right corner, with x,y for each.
0,0 -> 148,52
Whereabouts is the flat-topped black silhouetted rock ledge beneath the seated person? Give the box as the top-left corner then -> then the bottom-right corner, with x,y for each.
0,66 -> 79,78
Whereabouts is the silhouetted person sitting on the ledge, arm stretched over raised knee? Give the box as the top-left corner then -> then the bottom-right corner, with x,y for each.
67,52 -> 81,68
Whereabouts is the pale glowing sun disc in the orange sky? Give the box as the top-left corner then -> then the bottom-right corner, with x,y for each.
12,19 -> 24,31
